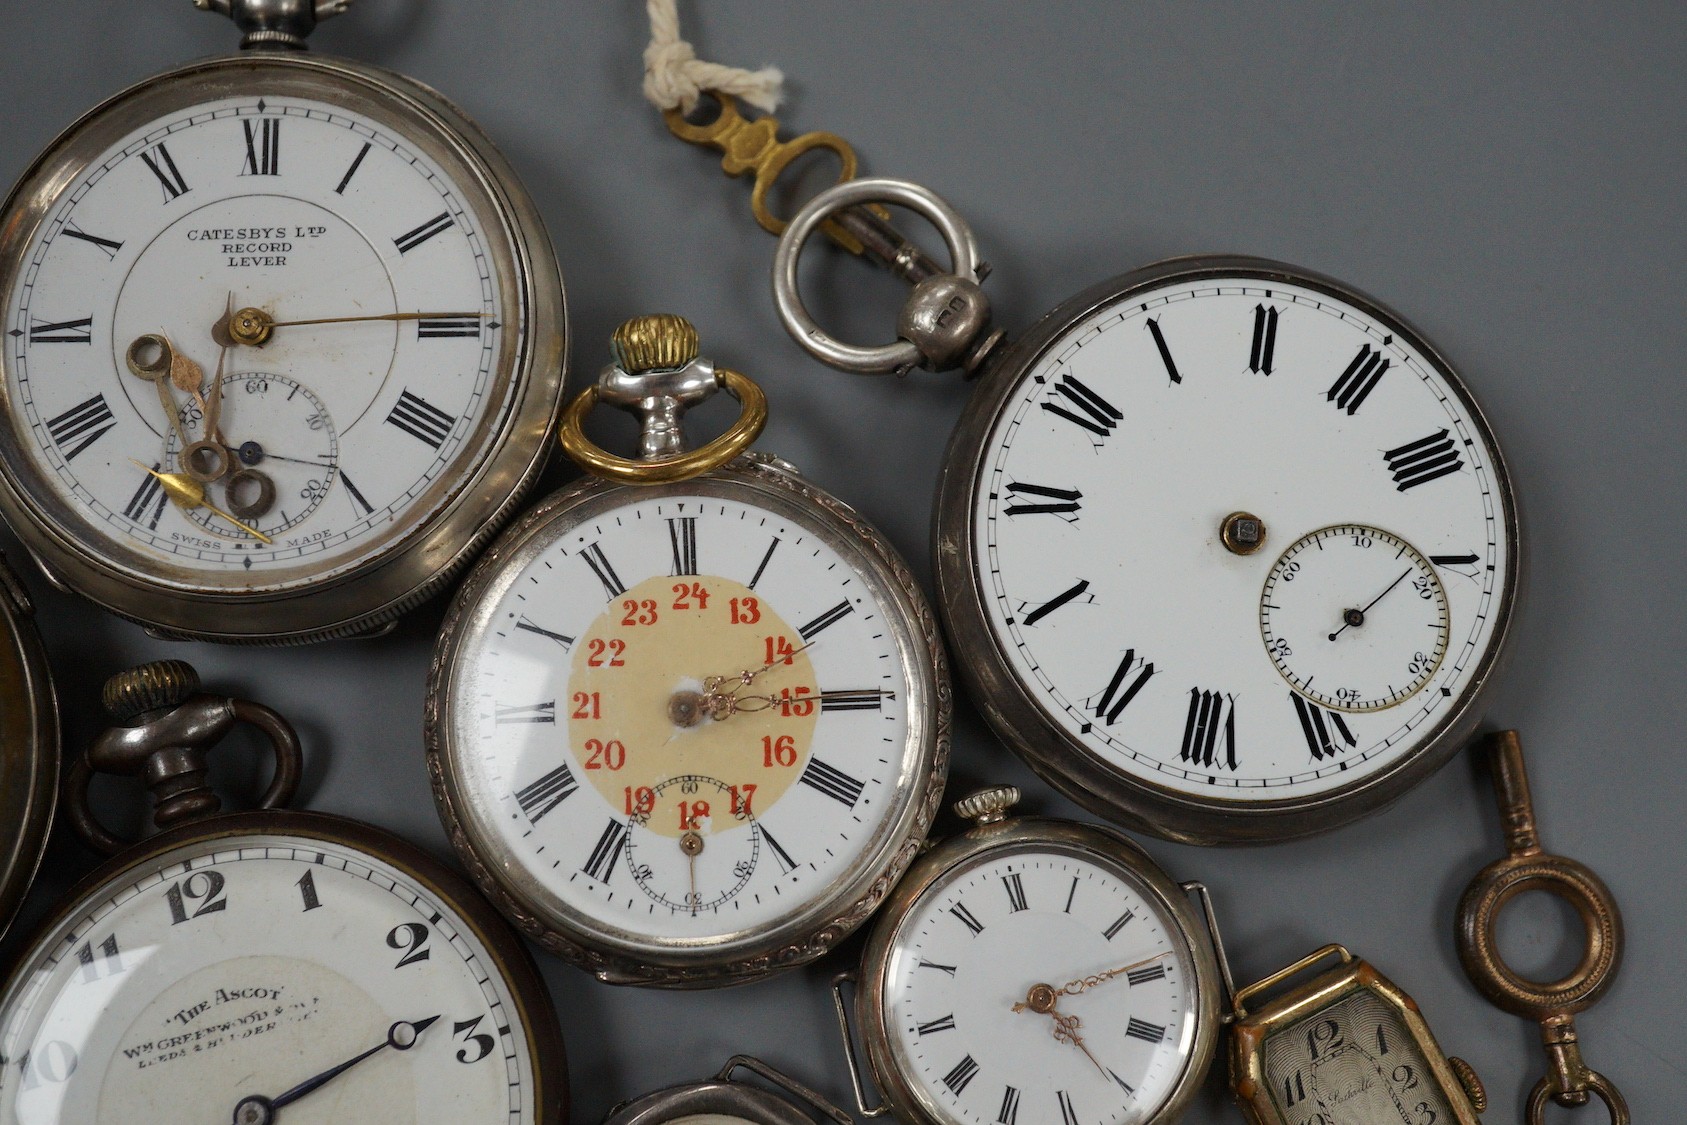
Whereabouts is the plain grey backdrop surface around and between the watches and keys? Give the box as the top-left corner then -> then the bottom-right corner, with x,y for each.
0,0 -> 1687,1123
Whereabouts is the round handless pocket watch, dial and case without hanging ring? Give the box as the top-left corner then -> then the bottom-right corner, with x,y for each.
936,258 -> 1522,843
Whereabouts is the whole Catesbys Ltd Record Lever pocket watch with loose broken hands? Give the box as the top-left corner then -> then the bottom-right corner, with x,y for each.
0,0 -> 563,643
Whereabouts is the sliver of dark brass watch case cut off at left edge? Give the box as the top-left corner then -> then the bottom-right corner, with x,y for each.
0,555 -> 59,934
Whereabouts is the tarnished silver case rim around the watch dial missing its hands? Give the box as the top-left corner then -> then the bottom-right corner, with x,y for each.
933,255 -> 1525,845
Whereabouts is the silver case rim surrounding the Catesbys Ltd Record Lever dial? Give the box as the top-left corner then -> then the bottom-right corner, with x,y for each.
0,52 -> 567,644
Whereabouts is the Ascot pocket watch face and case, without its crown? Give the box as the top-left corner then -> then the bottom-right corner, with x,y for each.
0,813 -> 565,1125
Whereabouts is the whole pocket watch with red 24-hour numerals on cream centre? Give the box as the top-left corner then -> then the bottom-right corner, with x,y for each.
427,315 -> 950,987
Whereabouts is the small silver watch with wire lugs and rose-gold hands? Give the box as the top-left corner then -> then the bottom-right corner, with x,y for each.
837,788 -> 1221,1125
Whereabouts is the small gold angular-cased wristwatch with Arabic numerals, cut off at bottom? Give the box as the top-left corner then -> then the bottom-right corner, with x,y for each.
1230,945 -> 1488,1125
